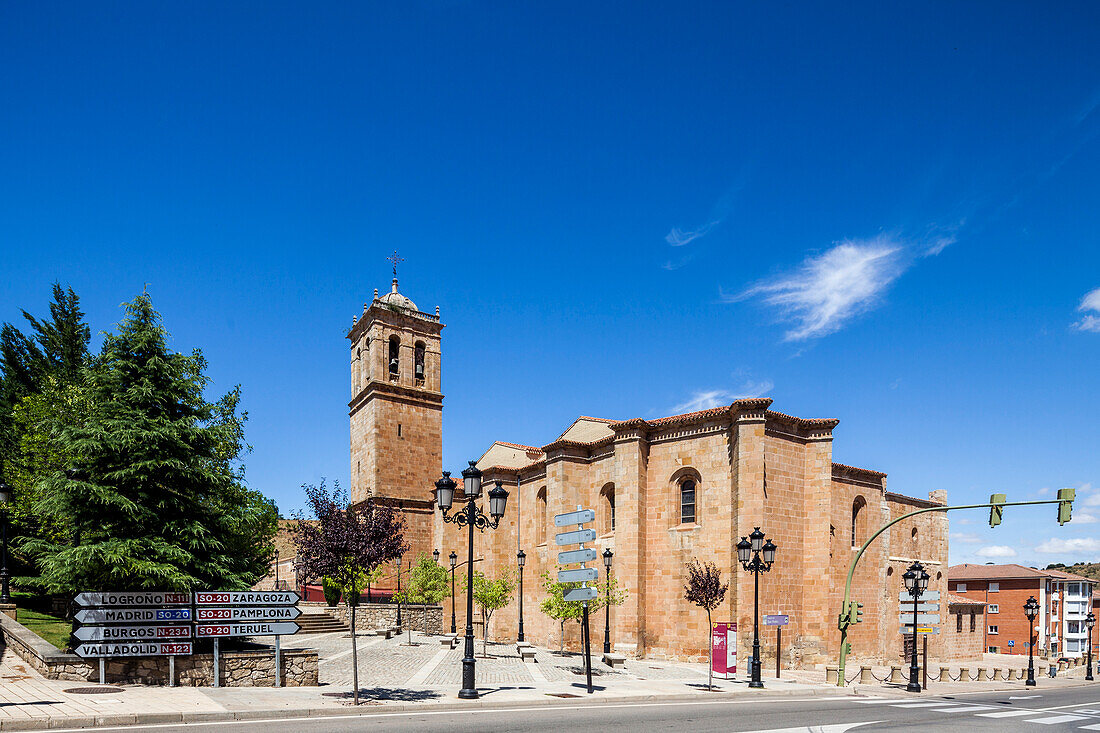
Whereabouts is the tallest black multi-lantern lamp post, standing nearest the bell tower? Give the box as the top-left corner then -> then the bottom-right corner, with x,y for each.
436,461 -> 508,700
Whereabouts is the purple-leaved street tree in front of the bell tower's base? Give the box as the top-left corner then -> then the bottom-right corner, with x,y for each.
292,481 -> 408,705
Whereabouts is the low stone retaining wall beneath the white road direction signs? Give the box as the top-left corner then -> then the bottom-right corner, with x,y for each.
0,614 -> 319,687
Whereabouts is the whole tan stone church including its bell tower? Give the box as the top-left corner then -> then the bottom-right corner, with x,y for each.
349,278 -> 947,667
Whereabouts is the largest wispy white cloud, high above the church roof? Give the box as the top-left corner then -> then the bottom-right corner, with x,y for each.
723,236 -> 906,341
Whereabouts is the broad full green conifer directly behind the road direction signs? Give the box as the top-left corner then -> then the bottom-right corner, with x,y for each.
22,294 -> 277,593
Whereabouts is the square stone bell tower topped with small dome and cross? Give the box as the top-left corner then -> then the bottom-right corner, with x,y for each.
348,252 -> 443,557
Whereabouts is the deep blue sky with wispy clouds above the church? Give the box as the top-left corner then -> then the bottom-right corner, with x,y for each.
0,0 -> 1100,564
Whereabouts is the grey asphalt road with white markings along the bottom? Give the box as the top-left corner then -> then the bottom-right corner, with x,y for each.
53,685 -> 1100,733
